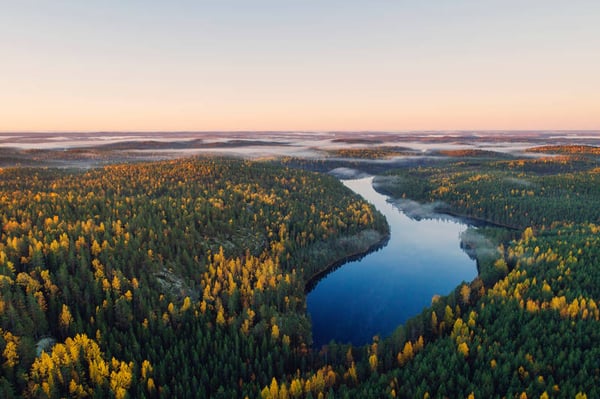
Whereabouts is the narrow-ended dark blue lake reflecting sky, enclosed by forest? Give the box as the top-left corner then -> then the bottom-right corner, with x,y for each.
307,178 -> 477,347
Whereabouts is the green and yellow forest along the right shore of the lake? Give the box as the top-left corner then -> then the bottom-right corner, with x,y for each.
308,146 -> 600,398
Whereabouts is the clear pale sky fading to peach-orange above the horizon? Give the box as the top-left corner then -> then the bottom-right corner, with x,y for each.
0,0 -> 600,132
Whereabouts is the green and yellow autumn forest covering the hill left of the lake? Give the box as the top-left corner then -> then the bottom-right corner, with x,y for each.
0,159 -> 387,398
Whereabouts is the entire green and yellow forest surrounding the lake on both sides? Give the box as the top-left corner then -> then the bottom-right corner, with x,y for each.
0,146 -> 600,399
